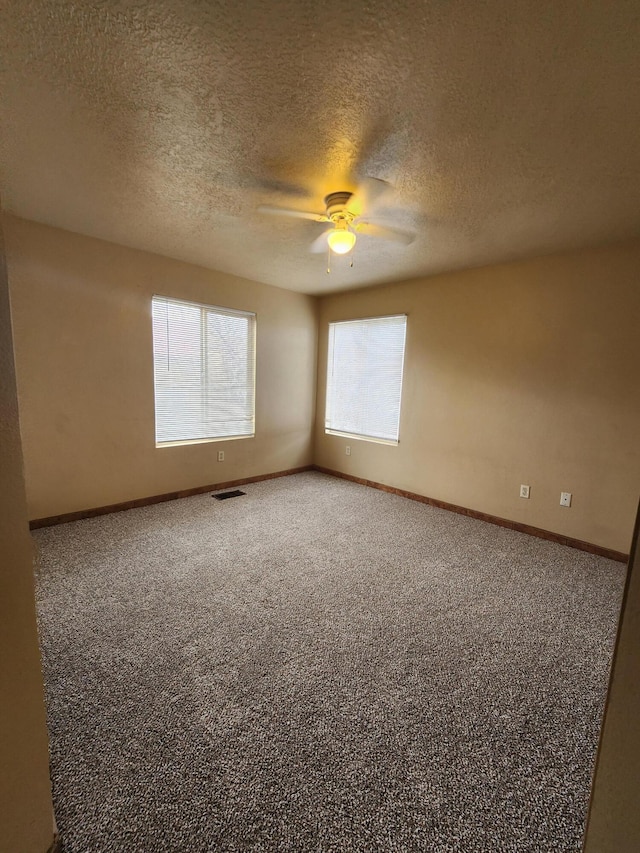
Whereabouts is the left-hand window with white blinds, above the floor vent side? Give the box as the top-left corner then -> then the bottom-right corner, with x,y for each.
152,296 -> 256,446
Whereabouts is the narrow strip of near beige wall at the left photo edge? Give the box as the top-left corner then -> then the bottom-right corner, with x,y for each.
0,215 -> 53,853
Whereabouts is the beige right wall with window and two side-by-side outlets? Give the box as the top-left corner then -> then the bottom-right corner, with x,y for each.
315,242 -> 640,553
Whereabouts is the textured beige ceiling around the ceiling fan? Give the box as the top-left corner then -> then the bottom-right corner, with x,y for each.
0,0 -> 640,293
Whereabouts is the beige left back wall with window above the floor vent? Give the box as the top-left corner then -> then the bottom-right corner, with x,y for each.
5,217 -> 317,518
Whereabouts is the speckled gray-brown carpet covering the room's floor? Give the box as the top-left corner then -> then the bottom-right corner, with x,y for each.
35,473 -> 625,853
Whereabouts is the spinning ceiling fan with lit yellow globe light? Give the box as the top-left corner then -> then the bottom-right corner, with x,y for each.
258,178 -> 415,255
